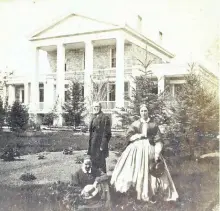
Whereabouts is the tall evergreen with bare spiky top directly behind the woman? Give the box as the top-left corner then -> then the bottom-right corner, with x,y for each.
115,48 -> 166,127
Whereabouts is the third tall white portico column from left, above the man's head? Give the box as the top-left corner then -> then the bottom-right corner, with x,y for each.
84,40 -> 93,103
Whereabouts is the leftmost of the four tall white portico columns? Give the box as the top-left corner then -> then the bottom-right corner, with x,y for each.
31,48 -> 39,115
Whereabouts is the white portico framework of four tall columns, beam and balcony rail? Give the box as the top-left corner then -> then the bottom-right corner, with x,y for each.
31,33 -> 131,125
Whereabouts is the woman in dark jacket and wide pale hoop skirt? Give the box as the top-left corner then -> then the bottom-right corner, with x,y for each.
111,105 -> 178,203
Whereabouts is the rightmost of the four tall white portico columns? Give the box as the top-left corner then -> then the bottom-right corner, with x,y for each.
115,36 -> 124,108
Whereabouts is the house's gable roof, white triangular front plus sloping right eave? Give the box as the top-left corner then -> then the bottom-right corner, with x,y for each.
30,12 -> 175,58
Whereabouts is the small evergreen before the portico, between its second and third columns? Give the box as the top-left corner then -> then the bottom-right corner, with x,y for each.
63,80 -> 85,128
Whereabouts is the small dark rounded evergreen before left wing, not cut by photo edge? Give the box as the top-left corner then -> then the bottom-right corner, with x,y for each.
8,101 -> 29,132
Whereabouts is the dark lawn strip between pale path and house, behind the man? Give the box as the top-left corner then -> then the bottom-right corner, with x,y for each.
0,131 -> 125,155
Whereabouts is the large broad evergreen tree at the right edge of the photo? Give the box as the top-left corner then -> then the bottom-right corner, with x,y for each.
165,64 -> 219,157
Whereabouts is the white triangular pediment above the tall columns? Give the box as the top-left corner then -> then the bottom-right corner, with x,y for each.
31,14 -> 117,40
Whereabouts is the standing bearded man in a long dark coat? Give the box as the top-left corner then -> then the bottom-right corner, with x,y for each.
88,102 -> 111,173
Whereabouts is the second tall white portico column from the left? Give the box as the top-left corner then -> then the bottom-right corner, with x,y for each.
56,44 -> 65,126
